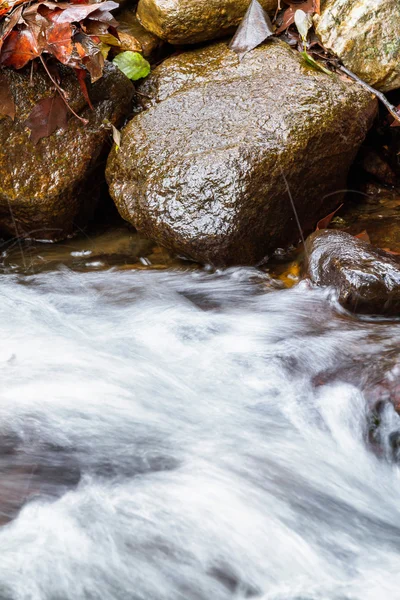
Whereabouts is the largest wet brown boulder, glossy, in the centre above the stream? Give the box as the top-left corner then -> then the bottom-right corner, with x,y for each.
107,41 -> 376,265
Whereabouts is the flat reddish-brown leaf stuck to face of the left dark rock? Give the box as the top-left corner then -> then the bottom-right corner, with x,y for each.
24,94 -> 68,144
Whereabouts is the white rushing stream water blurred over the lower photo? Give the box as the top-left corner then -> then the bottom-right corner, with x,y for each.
0,226 -> 400,600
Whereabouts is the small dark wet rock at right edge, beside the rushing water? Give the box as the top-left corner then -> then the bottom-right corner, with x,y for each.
305,229 -> 400,315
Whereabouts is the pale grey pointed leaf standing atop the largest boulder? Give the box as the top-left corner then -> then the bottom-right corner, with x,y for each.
229,0 -> 274,60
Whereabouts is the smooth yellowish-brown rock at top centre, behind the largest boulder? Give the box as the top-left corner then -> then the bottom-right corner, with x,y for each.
137,0 -> 278,45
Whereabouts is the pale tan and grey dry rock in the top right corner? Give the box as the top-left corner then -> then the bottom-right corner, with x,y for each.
315,0 -> 400,92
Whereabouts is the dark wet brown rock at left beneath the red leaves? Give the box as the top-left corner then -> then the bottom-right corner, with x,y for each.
0,64 -> 133,240
